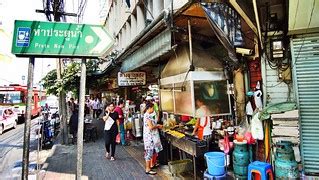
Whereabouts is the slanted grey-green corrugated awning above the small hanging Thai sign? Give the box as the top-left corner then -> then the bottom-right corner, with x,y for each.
121,29 -> 172,72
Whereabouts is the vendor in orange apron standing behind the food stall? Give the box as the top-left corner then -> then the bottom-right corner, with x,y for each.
193,98 -> 212,140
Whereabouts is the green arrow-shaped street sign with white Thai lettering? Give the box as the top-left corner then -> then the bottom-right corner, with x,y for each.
12,20 -> 114,57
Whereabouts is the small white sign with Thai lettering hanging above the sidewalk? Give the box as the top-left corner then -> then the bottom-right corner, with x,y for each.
117,72 -> 146,86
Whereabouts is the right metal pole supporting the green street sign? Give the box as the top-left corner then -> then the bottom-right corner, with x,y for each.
76,58 -> 86,180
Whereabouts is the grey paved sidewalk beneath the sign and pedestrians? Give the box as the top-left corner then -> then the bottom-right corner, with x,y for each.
40,121 -> 170,180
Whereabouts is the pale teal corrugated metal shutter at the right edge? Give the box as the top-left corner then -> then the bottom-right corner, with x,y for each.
291,34 -> 319,174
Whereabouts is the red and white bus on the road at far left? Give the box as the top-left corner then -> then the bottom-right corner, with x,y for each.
0,84 -> 46,123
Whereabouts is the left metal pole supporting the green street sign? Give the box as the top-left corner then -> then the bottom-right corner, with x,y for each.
22,57 -> 34,180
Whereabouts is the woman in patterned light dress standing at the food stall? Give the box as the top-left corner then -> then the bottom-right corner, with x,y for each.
143,102 -> 163,175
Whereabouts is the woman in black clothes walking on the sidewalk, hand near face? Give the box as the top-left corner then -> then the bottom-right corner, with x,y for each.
103,102 -> 119,161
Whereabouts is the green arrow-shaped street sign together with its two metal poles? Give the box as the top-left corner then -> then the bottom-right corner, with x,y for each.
12,20 -> 114,179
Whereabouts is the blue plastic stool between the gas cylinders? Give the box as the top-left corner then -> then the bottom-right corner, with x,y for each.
248,161 -> 274,180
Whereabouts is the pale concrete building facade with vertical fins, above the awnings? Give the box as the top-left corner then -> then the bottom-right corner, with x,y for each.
103,0 -> 189,50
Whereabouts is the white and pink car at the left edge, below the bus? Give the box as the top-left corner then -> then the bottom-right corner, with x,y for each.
0,107 -> 18,135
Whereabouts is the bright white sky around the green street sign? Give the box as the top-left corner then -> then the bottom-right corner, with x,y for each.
0,0 -> 100,86
